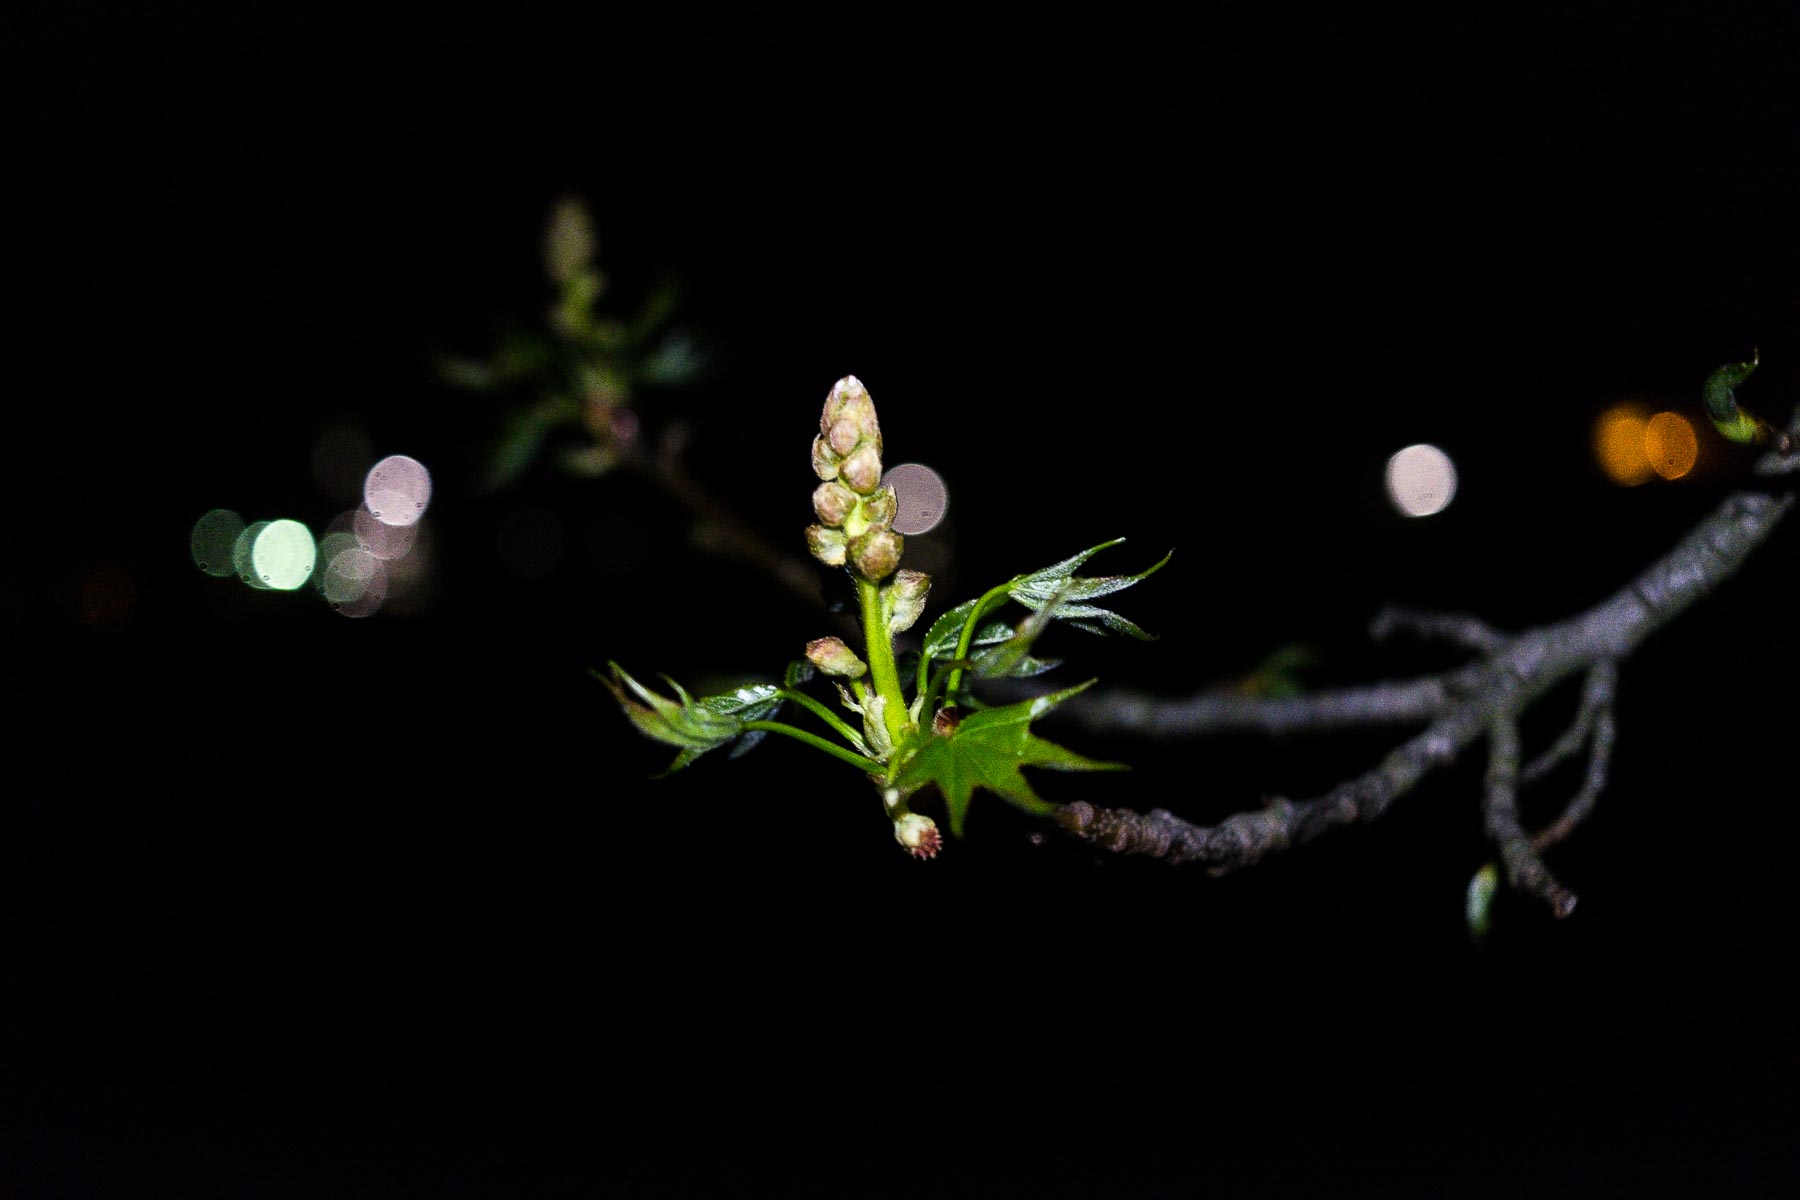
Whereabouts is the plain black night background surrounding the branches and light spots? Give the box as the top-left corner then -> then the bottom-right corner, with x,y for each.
0,4 -> 1800,1196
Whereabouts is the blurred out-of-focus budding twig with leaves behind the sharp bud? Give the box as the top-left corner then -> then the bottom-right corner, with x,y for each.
437,198 -> 823,606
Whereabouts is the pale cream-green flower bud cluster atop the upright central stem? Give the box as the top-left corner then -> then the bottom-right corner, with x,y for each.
806,374 -> 905,583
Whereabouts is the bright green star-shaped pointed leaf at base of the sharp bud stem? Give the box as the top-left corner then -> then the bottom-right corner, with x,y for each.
893,680 -> 1123,835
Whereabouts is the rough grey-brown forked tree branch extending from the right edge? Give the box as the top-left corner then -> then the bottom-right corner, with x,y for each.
1057,424 -> 1800,918
